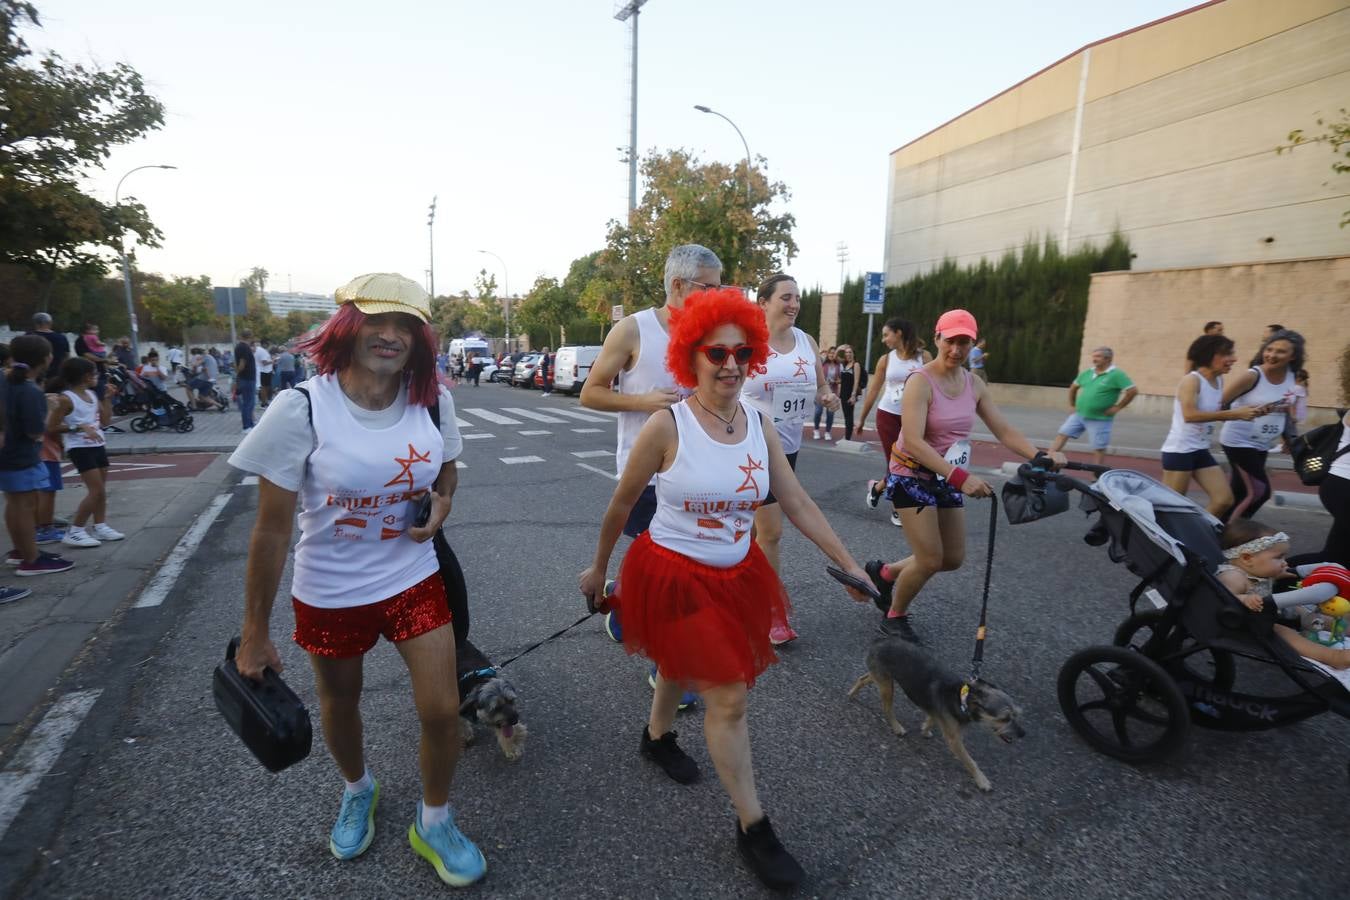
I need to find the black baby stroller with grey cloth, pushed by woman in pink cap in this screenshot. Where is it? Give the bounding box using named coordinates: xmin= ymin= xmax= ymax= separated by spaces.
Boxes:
xmin=1003 ymin=461 xmax=1350 ymax=762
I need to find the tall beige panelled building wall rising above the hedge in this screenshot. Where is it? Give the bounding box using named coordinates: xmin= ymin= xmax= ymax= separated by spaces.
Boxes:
xmin=886 ymin=0 xmax=1350 ymax=283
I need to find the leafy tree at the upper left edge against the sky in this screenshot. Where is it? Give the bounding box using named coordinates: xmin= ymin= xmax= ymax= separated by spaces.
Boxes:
xmin=0 ymin=0 xmax=163 ymax=290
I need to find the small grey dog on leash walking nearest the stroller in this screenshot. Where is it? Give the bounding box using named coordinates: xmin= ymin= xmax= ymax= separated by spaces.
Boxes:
xmin=848 ymin=637 xmax=1026 ymax=791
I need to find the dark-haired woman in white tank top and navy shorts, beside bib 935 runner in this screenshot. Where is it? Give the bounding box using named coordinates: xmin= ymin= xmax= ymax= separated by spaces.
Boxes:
xmin=1162 ymin=335 xmax=1261 ymax=518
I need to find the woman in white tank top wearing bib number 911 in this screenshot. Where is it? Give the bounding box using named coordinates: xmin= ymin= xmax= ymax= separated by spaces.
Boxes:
xmin=741 ymin=275 xmax=840 ymax=644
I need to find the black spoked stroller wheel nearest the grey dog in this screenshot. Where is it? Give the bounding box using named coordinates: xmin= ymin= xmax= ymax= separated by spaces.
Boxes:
xmin=1057 ymin=646 xmax=1191 ymax=762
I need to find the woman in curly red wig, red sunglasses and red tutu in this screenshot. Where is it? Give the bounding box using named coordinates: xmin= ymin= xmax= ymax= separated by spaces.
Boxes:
xmin=581 ymin=289 xmax=867 ymax=888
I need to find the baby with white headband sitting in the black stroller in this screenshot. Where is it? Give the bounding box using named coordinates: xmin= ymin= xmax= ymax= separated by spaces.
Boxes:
xmin=1216 ymin=518 xmax=1350 ymax=669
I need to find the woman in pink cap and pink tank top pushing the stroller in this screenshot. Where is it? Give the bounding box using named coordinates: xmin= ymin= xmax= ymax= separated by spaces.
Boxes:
xmin=864 ymin=309 xmax=1067 ymax=644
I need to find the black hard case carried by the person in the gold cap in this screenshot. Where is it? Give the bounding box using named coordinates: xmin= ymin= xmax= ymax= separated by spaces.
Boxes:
xmin=211 ymin=637 xmax=315 ymax=772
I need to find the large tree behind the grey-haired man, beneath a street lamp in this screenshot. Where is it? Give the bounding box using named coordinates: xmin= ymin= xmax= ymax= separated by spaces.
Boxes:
xmin=599 ymin=150 xmax=797 ymax=312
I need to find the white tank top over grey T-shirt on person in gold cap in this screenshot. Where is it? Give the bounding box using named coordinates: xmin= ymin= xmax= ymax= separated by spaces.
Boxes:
xmin=290 ymin=375 xmax=444 ymax=609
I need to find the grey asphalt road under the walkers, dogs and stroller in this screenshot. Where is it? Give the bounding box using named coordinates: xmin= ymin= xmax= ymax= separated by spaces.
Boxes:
xmin=0 ymin=385 xmax=1350 ymax=899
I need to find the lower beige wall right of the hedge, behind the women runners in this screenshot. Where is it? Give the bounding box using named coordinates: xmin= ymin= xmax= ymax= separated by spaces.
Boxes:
xmin=1079 ymin=256 xmax=1350 ymax=407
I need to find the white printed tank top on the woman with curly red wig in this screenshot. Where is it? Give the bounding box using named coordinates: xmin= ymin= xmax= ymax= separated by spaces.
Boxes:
xmin=648 ymin=399 xmax=770 ymax=568
